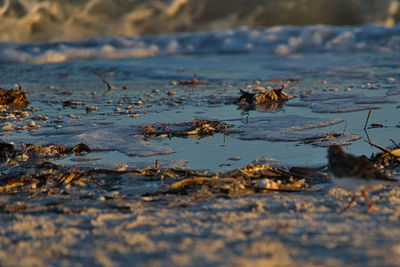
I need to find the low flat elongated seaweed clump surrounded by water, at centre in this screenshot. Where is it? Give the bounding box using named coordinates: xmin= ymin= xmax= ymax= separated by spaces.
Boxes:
xmin=138 ymin=120 xmax=229 ymax=139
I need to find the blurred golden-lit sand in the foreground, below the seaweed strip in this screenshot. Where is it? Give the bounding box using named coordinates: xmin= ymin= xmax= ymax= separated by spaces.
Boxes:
xmin=0 ymin=176 xmax=400 ymax=266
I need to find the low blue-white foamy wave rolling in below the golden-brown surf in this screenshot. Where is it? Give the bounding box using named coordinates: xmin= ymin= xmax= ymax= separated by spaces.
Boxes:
xmin=0 ymin=24 xmax=400 ymax=64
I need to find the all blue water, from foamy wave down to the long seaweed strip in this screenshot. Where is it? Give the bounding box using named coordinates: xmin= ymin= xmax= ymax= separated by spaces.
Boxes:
xmin=0 ymin=24 xmax=400 ymax=171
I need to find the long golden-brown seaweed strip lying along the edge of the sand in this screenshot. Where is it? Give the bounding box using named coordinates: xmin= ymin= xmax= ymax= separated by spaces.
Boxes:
xmin=0 ymin=153 xmax=325 ymax=201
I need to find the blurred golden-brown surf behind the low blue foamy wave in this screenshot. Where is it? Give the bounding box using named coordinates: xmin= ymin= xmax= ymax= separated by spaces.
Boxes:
xmin=0 ymin=0 xmax=400 ymax=42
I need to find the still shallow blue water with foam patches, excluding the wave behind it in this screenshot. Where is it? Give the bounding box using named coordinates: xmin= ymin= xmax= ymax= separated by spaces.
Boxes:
xmin=0 ymin=52 xmax=400 ymax=171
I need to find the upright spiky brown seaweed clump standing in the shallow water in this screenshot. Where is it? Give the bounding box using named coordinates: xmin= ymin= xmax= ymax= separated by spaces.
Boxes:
xmin=237 ymin=86 xmax=293 ymax=110
